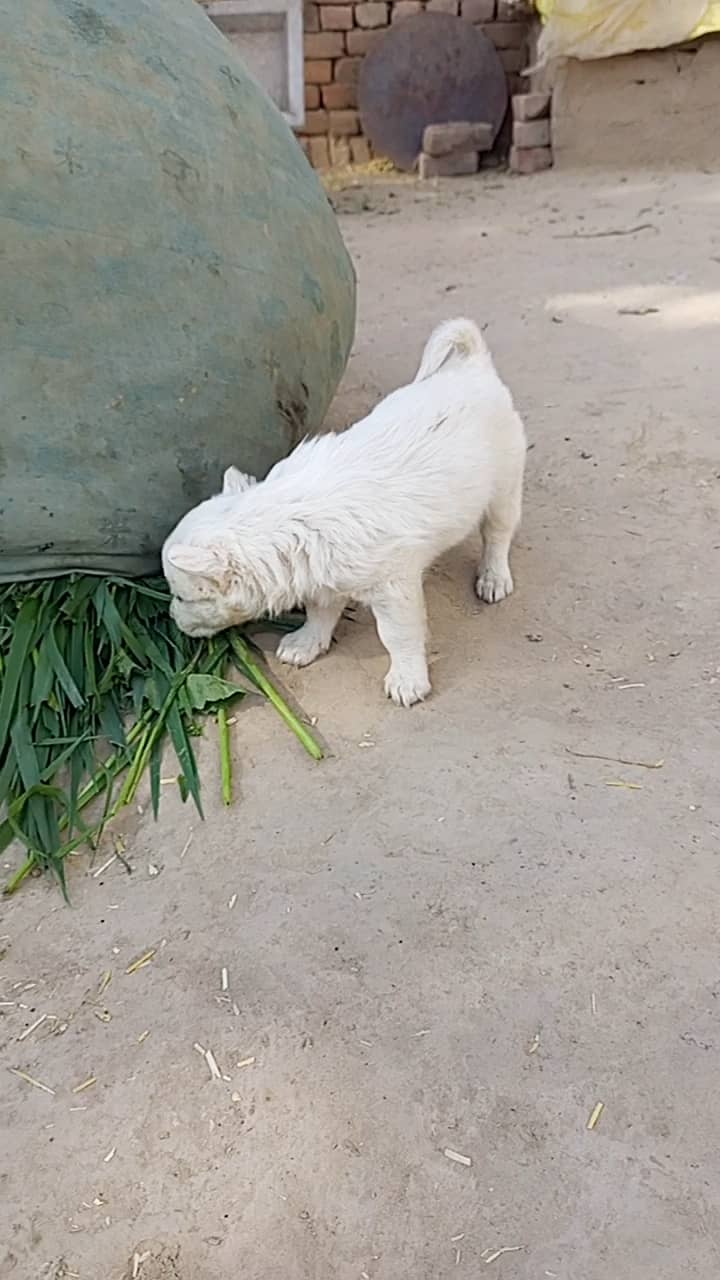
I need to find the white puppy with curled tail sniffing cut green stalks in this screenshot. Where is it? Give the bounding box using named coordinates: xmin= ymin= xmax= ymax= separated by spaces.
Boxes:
xmin=163 ymin=320 xmax=525 ymax=707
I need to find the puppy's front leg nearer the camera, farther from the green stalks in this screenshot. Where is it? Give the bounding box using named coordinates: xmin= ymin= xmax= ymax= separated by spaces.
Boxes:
xmin=370 ymin=575 xmax=430 ymax=707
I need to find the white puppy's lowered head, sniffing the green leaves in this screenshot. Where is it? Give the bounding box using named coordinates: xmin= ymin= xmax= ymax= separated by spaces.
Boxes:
xmin=163 ymin=467 xmax=265 ymax=636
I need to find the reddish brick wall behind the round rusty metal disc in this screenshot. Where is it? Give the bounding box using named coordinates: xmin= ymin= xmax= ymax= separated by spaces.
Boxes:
xmin=297 ymin=0 xmax=529 ymax=169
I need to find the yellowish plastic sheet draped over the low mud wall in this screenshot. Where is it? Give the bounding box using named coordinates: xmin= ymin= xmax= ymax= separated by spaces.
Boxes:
xmin=536 ymin=0 xmax=720 ymax=63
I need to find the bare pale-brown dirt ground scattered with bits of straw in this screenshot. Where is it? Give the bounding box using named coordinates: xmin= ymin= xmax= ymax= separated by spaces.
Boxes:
xmin=0 ymin=173 xmax=720 ymax=1280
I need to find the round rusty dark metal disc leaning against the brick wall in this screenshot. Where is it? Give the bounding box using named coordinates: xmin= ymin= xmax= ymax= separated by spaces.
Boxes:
xmin=357 ymin=13 xmax=507 ymax=169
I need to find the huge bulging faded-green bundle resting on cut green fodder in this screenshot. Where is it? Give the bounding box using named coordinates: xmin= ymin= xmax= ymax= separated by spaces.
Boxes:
xmin=0 ymin=0 xmax=355 ymax=580
